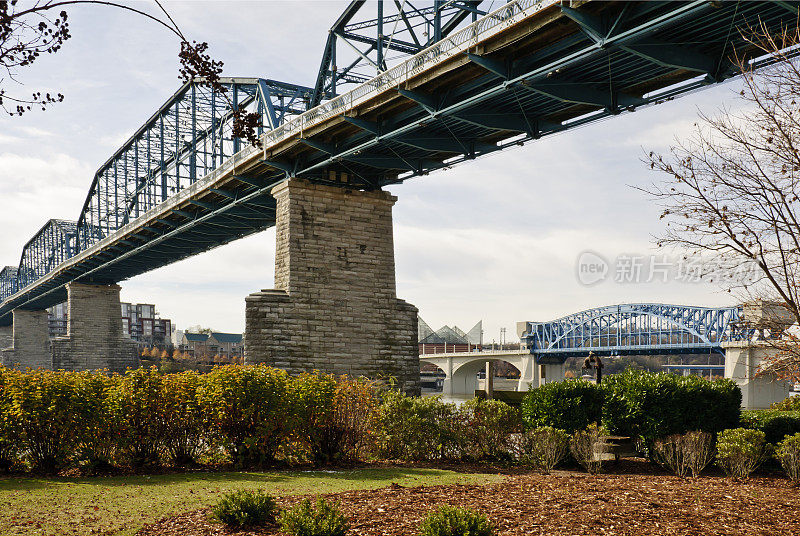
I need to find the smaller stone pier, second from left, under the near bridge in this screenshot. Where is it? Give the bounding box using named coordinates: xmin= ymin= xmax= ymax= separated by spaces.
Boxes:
xmin=53 ymin=283 xmax=139 ymax=373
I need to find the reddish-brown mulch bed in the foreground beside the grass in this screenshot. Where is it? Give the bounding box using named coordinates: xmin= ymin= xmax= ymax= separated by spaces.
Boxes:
xmin=137 ymin=466 xmax=800 ymax=536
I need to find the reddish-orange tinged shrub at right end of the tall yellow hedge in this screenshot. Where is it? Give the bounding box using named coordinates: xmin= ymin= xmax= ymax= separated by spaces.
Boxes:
xmin=293 ymin=373 xmax=378 ymax=463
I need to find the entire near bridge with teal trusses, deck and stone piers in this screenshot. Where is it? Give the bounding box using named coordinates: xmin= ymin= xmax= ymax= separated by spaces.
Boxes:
xmin=0 ymin=0 xmax=800 ymax=388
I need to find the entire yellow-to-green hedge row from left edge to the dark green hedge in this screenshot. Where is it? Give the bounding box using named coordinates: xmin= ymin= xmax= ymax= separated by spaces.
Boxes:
xmin=0 ymin=365 xmax=520 ymax=473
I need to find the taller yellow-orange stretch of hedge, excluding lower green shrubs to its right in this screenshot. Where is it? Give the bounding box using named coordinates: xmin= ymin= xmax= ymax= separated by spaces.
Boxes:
xmin=0 ymin=365 xmax=378 ymax=472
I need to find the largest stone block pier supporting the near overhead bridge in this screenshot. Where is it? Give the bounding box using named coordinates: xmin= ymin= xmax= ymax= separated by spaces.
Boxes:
xmin=245 ymin=179 xmax=419 ymax=393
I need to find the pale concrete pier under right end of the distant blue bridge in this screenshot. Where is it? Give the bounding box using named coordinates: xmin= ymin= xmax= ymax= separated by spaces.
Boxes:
xmin=722 ymin=341 xmax=792 ymax=409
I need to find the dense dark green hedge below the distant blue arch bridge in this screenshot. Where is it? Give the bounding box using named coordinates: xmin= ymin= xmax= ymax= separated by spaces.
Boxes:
xmin=522 ymin=370 xmax=742 ymax=447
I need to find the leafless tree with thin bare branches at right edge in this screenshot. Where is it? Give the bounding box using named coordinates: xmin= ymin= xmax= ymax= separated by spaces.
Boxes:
xmin=645 ymin=19 xmax=800 ymax=378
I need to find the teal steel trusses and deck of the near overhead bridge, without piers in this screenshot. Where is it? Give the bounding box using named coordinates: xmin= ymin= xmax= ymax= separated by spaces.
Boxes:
xmin=0 ymin=0 xmax=800 ymax=324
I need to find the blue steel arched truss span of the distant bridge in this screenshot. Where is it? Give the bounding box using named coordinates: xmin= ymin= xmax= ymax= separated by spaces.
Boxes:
xmin=522 ymin=303 xmax=754 ymax=363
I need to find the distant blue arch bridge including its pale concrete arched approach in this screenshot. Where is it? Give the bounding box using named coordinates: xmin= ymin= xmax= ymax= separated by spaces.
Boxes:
xmin=420 ymin=303 xmax=756 ymax=395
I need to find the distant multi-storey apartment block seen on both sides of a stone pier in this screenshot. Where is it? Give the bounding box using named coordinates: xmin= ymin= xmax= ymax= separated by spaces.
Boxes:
xmin=47 ymin=303 xmax=173 ymax=347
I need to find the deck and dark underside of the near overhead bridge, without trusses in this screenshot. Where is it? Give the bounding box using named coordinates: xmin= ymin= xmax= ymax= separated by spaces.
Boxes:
xmin=0 ymin=0 xmax=800 ymax=323
